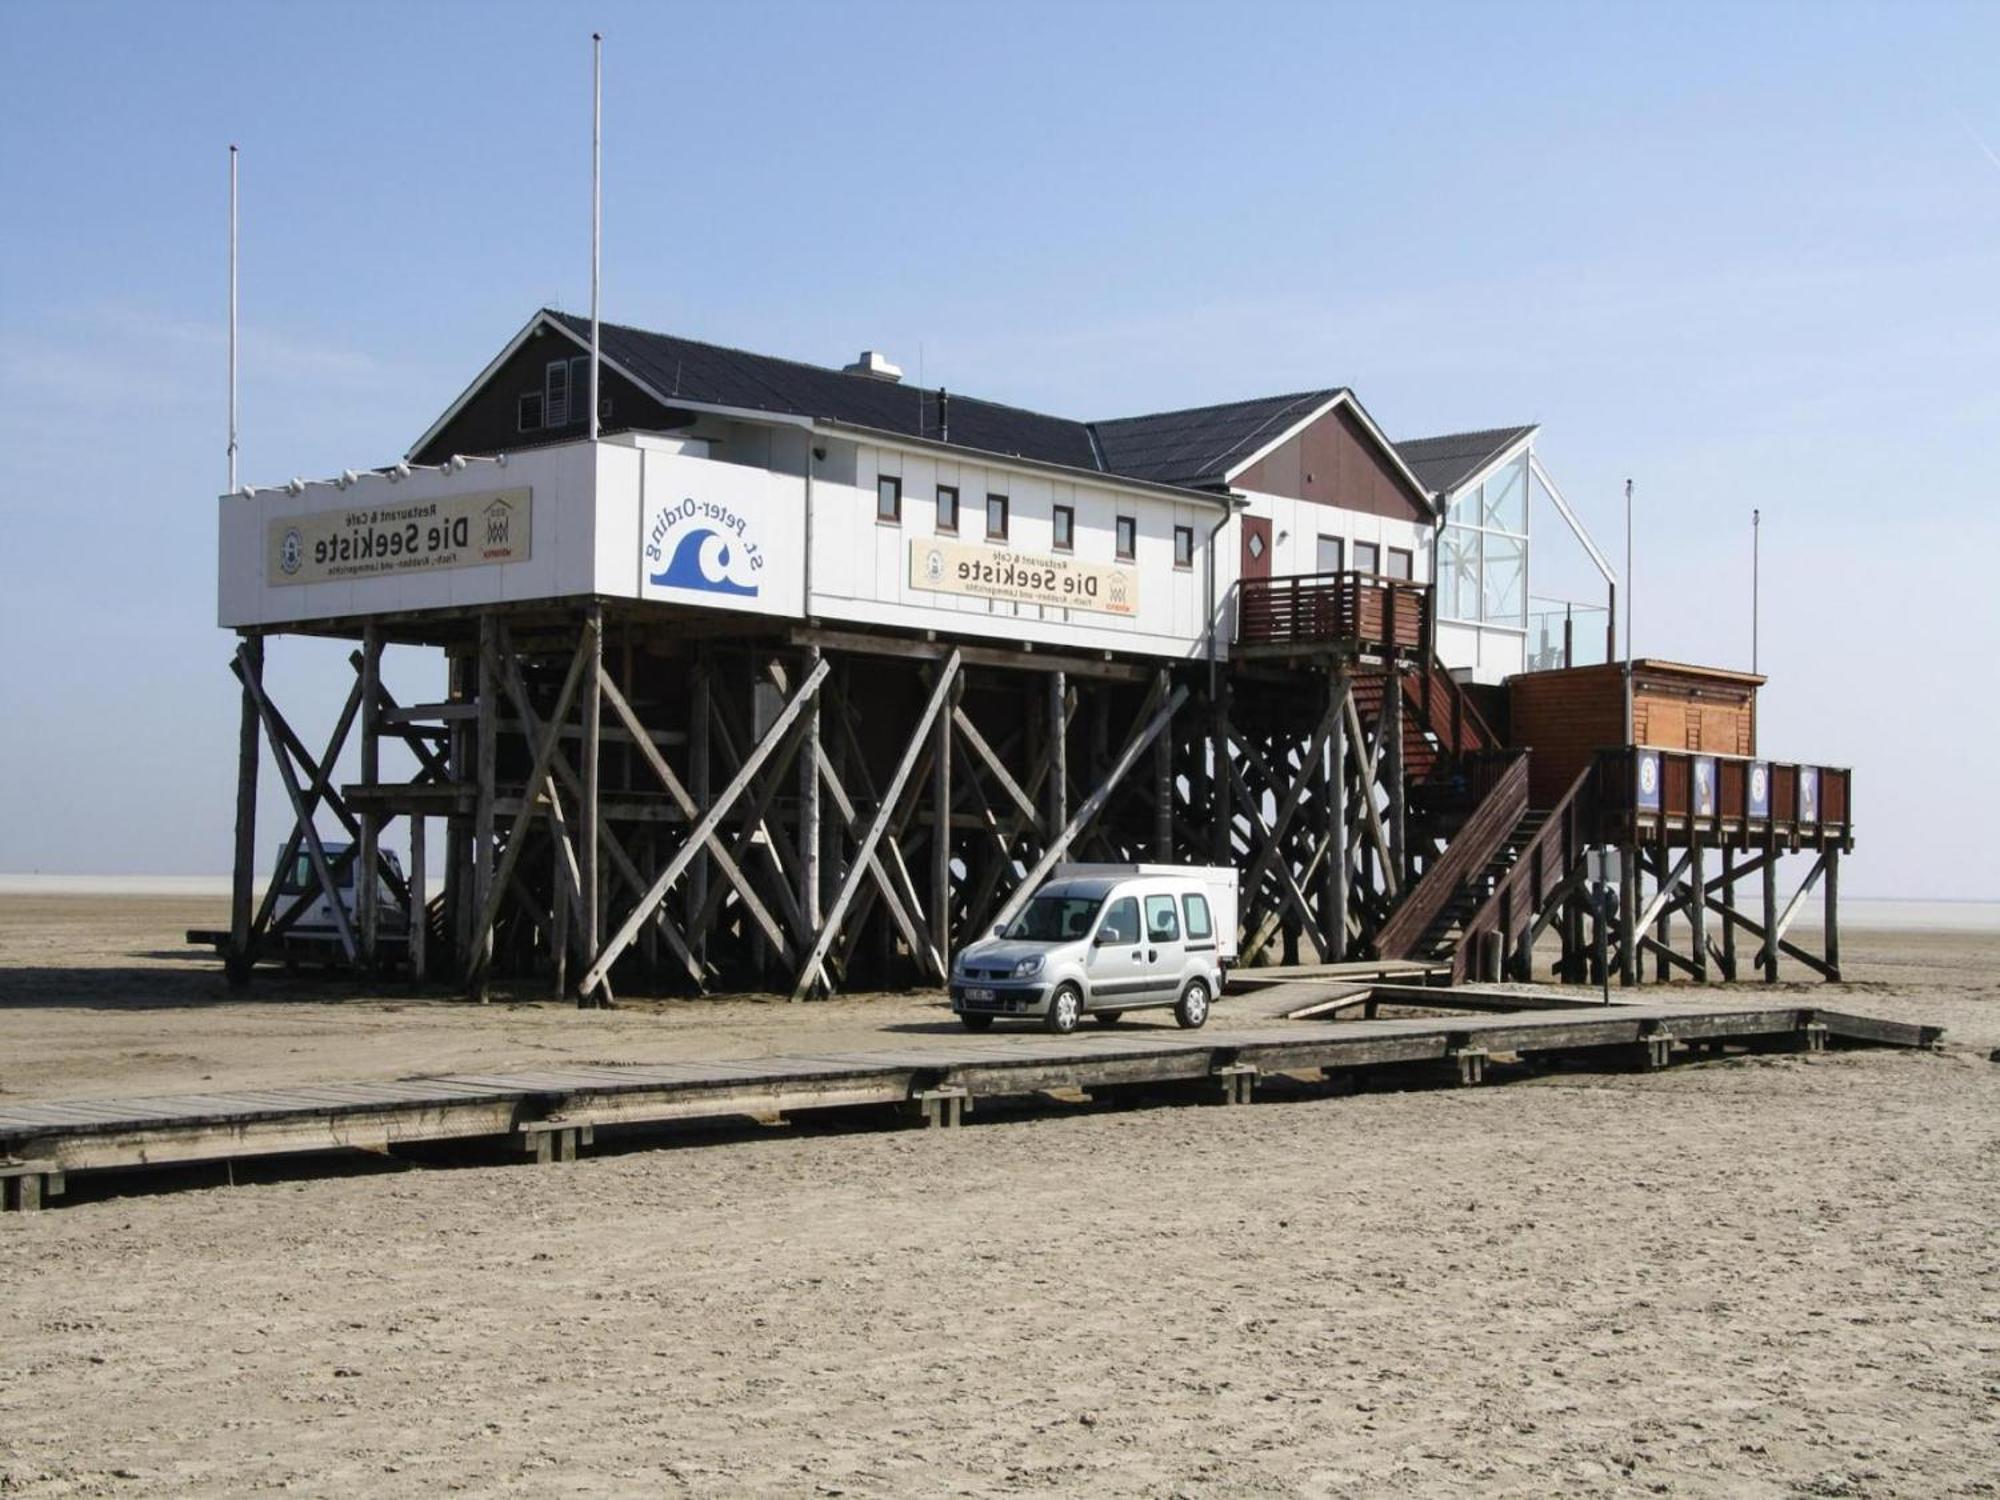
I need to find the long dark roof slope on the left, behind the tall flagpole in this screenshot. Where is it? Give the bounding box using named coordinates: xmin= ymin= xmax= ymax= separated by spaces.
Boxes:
xmin=548 ymin=312 xmax=1098 ymax=478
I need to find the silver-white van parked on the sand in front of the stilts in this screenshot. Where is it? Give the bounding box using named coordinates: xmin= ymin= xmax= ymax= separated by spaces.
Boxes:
xmin=952 ymin=864 xmax=1236 ymax=1034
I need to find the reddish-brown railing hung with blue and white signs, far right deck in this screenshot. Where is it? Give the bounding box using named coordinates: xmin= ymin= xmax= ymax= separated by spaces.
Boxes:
xmin=1598 ymin=746 xmax=1854 ymax=842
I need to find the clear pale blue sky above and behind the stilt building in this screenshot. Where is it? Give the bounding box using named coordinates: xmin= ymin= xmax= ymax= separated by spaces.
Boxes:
xmin=0 ymin=0 xmax=2000 ymax=896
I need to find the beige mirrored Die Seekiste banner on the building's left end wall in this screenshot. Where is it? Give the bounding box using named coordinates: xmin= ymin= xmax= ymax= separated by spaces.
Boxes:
xmin=264 ymin=488 xmax=534 ymax=584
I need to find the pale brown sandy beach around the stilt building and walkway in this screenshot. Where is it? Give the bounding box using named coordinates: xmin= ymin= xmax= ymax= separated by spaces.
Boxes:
xmin=0 ymin=896 xmax=2000 ymax=1496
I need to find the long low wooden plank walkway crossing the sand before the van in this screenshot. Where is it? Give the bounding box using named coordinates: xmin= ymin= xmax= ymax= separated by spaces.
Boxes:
xmin=0 ymin=992 xmax=1942 ymax=1208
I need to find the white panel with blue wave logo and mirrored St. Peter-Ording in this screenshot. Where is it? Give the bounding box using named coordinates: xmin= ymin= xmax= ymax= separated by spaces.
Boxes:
xmin=638 ymin=454 xmax=806 ymax=614
